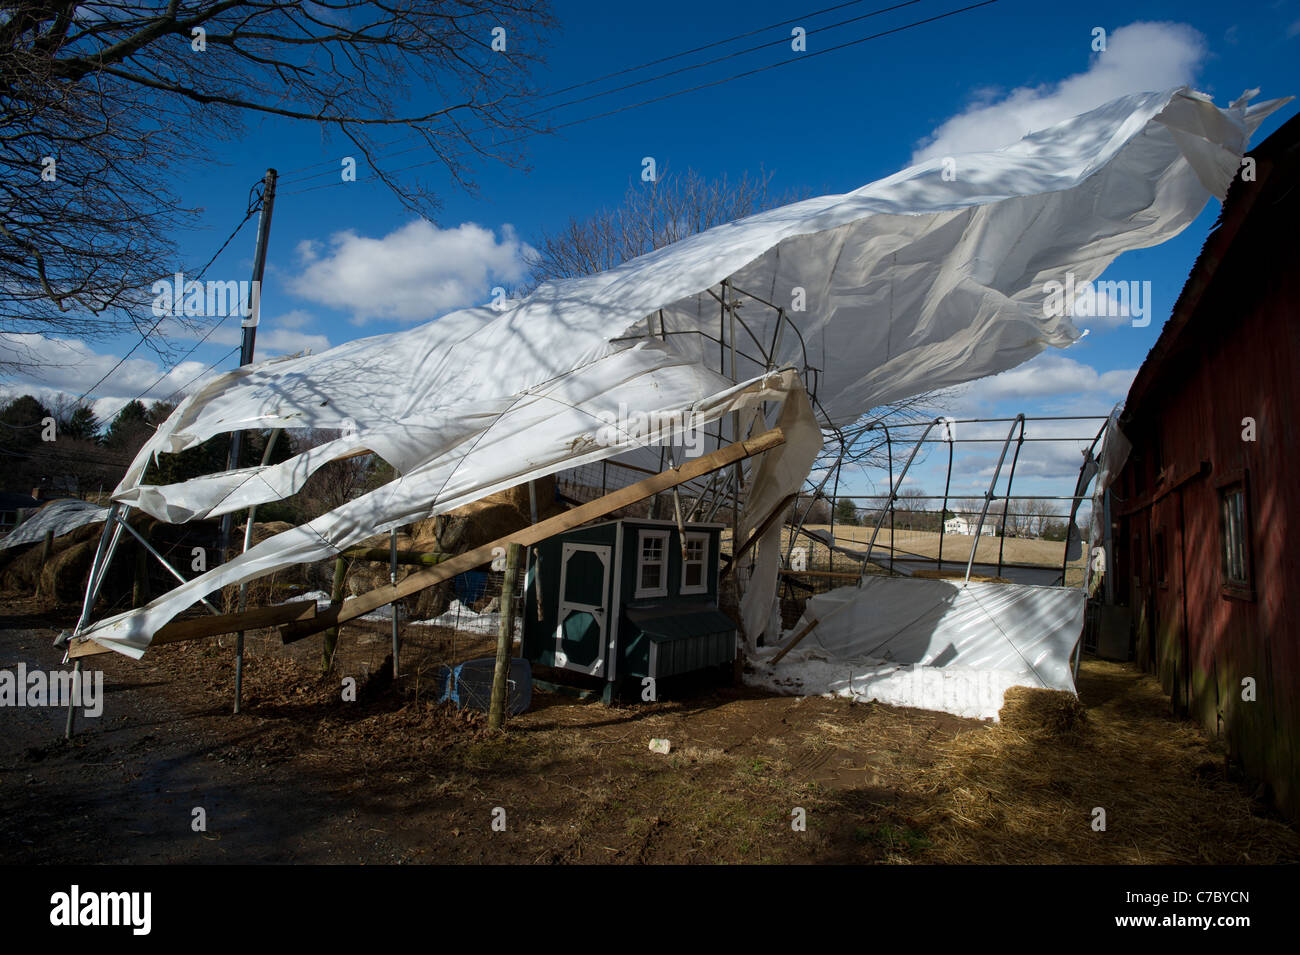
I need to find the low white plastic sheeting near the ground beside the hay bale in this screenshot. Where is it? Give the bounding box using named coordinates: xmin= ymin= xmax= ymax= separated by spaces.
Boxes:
xmin=745 ymin=577 xmax=1087 ymax=719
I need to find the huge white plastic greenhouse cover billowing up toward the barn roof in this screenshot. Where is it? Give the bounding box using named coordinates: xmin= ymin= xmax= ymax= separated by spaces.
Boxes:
xmin=76 ymin=88 xmax=1281 ymax=656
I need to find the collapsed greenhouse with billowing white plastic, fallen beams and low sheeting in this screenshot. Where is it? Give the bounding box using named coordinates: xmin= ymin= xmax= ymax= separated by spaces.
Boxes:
xmin=53 ymin=87 xmax=1279 ymax=712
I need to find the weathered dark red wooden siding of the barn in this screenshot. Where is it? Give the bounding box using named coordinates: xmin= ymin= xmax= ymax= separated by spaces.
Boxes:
xmin=1117 ymin=143 xmax=1300 ymax=817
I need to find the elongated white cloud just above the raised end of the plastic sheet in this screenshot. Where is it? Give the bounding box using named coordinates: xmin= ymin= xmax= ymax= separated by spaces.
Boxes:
xmin=911 ymin=22 xmax=1206 ymax=162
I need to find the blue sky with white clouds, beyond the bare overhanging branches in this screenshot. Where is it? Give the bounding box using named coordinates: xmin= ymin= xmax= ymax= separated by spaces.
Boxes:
xmin=5 ymin=0 xmax=1300 ymax=514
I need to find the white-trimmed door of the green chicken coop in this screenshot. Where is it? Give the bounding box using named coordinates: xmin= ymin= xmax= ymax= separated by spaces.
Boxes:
xmin=555 ymin=543 xmax=611 ymax=677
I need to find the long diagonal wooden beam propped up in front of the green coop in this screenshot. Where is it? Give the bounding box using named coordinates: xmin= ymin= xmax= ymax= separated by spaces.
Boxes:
xmin=282 ymin=427 xmax=785 ymax=642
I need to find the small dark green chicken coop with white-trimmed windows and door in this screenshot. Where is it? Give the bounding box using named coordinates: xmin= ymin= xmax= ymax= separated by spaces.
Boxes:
xmin=523 ymin=518 xmax=736 ymax=700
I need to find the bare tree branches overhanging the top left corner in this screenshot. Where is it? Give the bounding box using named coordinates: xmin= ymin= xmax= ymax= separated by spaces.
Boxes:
xmin=0 ymin=0 xmax=551 ymax=370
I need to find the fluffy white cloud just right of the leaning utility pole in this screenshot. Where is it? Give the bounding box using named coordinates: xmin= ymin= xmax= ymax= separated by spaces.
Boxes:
xmin=290 ymin=220 xmax=530 ymax=322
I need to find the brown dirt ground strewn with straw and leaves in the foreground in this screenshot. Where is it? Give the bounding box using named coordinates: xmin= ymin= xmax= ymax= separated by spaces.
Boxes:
xmin=0 ymin=595 xmax=1300 ymax=863
